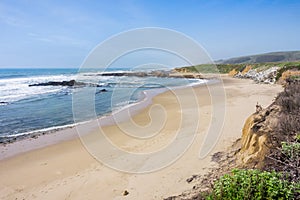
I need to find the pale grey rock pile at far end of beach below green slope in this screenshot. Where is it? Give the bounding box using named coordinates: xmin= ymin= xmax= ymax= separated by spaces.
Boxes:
xmin=234 ymin=67 xmax=278 ymax=84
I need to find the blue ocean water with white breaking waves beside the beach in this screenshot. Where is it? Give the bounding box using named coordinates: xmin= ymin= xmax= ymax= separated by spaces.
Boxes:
xmin=0 ymin=68 xmax=204 ymax=139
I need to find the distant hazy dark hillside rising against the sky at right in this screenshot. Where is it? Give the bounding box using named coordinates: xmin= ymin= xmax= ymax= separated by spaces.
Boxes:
xmin=216 ymin=51 xmax=300 ymax=64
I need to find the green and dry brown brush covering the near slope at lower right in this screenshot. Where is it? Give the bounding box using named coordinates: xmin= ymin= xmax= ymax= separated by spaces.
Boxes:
xmin=199 ymin=81 xmax=300 ymax=200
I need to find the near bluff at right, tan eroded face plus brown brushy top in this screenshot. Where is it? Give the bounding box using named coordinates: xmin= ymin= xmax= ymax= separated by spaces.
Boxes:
xmin=237 ymin=80 xmax=300 ymax=167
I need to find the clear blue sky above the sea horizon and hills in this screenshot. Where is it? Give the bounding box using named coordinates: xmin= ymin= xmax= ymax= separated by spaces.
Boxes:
xmin=0 ymin=0 xmax=300 ymax=68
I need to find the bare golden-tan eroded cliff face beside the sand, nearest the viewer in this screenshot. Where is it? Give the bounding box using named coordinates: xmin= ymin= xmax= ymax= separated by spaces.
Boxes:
xmin=237 ymin=103 xmax=280 ymax=168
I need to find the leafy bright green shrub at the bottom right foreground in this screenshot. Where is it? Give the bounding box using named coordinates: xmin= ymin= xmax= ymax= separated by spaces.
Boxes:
xmin=206 ymin=170 xmax=296 ymax=200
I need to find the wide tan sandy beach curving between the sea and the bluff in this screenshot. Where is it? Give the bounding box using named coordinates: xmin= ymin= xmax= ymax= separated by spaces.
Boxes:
xmin=0 ymin=76 xmax=282 ymax=200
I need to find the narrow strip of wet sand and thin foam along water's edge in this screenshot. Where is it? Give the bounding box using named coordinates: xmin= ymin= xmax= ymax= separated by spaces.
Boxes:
xmin=0 ymin=79 xmax=209 ymax=161
